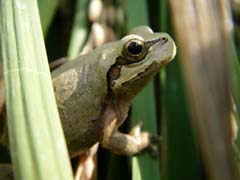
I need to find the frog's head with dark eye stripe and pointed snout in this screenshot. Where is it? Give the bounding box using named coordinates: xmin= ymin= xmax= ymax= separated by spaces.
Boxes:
xmin=108 ymin=26 xmax=176 ymax=99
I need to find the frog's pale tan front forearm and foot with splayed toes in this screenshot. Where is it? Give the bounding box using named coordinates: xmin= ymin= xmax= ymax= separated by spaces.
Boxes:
xmin=101 ymin=123 xmax=160 ymax=157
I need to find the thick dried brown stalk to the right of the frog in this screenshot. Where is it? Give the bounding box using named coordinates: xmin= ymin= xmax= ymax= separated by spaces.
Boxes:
xmin=170 ymin=0 xmax=237 ymax=180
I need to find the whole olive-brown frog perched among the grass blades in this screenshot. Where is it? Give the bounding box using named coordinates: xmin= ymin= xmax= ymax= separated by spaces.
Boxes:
xmin=52 ymin=26 xmax=176 ymax=155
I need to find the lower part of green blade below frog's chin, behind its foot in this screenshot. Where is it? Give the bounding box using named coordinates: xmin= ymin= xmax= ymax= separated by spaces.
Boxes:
xmin=132 ymin=84 xmax=160 ymax=180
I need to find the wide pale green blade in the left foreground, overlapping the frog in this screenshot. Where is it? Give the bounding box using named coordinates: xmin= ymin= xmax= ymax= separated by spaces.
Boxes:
xmin=0 ymin=0 xmax=72 ymax=180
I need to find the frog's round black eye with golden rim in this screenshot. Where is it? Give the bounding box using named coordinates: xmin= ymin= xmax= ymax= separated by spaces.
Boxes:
xmin=123 ymin=39 xmax=147 ymax=63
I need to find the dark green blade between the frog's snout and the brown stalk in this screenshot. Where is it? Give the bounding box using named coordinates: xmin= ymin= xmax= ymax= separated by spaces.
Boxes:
xmin=159 ymin=0 xmax=201 ymax=180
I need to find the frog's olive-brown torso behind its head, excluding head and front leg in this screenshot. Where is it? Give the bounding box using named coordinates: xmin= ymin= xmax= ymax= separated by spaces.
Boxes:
xmin=52 ymin=48 xmax=111 ymax=154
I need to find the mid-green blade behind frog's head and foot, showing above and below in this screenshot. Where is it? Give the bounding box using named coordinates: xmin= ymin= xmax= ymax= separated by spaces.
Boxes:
xmin=126 ymin=0 xmax=160 ymax=180
